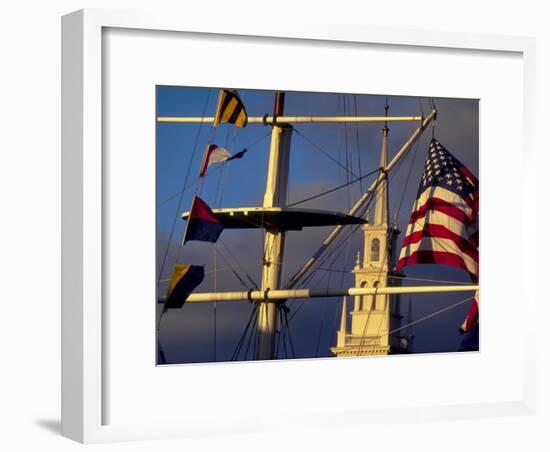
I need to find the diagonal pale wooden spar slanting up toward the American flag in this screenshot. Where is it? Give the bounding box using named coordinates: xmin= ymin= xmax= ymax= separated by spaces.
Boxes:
xmin=288 ymin=109 xmax=437 ymax=289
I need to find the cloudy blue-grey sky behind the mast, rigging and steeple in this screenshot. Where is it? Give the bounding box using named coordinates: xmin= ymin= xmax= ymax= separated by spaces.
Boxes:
xmin=156 ymin=87 xmax=478 ymax=363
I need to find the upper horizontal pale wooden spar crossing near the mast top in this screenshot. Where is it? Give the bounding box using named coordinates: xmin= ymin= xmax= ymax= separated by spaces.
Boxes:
xmin=157 ymin=116 xmax=423 ymax=124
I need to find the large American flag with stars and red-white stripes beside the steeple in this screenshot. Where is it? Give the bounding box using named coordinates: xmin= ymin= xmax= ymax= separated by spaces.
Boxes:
xmin=396 ymin=139 xmax=479 ymax=282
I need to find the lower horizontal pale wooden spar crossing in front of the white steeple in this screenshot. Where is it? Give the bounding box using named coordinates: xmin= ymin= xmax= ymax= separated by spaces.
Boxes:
xmin=159 ymin=284 xmax=479 ymax=304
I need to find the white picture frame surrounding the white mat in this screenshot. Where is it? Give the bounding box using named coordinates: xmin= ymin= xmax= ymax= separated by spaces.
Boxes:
xmin=62 ymin=10 xmax=536 ymax=443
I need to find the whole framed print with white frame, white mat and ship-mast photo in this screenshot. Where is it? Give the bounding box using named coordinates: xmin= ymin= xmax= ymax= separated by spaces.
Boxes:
xmin=62 ymin=10 xmax=534 ymax=442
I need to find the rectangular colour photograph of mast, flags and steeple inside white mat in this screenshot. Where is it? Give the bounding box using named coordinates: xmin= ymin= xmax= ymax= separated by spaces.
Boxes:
xmin=155 ymin=85 xmax=481 ymax=366
